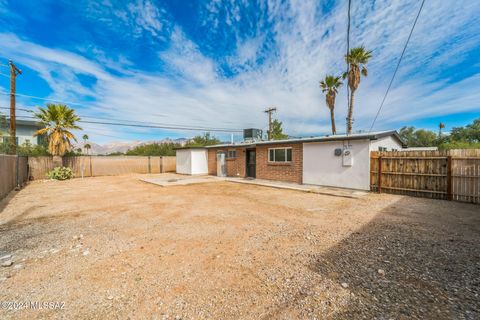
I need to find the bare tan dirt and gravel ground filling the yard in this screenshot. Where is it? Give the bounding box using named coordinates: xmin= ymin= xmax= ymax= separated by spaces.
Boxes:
xmin=0 ymin=176 xmax=480 ymax=319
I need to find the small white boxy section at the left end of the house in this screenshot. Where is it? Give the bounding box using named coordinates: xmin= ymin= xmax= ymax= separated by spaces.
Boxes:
xmin=176 ymin=149 xmax=208 ymax=174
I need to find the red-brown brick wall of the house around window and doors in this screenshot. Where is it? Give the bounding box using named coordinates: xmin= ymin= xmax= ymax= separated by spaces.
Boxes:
xmin=208 ymin=143 xmax=303 ymax=183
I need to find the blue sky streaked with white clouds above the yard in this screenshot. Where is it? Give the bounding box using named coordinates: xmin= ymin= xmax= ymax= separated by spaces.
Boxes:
xmin=0 ymin=0 xmax=480 ymax=143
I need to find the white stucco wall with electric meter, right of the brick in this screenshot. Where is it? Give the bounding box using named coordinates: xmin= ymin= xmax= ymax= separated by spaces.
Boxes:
xmin=303 ymin=140 xmax=370 ymax=190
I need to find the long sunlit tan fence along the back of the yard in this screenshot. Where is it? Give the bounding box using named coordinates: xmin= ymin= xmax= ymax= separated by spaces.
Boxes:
xmin=28 ymin=156 xmax=175 ymax=179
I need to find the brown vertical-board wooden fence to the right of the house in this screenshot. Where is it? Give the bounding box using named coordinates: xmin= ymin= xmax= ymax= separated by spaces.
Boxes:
xmin=370 ymin=149 xmax=480 ymax=203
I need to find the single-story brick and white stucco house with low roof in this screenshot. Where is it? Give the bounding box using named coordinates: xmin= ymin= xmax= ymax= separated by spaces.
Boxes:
xmin=177 ymin=131 xmax=404 ymax=190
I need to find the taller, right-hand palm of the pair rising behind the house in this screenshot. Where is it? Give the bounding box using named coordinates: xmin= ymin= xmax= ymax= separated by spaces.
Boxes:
xmin=343 ymin=46 xmax=372 ymax=134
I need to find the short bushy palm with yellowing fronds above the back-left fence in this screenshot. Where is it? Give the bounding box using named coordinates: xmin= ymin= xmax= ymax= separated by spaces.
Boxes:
xmin=34 ymin=103 xmax=82 ymax=156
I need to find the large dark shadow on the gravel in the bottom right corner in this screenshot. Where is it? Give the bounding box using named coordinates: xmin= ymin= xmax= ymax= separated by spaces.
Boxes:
xmin=311 ymin=197 xmax=480 ymax=319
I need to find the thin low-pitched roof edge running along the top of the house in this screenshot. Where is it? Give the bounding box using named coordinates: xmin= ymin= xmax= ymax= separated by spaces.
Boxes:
xmin=204 ymin=130 xmax=405 ymax=148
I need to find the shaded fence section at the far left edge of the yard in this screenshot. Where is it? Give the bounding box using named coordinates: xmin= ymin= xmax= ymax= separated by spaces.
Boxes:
xmin=0 ymin=155 xmax=28 ymax=199
